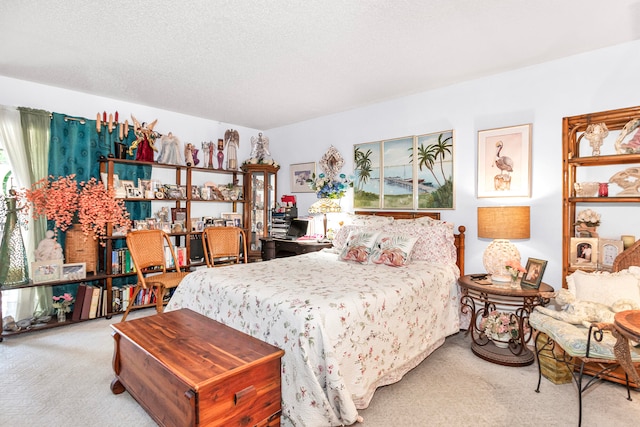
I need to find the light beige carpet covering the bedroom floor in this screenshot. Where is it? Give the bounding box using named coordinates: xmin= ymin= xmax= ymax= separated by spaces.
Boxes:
xmin=0 ymin=309 xmax=640 ymax=427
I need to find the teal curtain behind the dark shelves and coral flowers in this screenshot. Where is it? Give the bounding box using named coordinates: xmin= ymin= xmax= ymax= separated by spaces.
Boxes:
xmin=49 ymin=113 xmax=152 ymax=295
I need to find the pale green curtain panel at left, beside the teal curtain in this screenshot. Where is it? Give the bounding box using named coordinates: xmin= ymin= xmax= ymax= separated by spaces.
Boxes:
xmin=18 ymin=107 xmax=53 ymax=317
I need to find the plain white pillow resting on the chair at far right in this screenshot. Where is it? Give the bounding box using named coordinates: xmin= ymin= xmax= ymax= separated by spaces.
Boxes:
xmin=567 ymin=270 xmax=640 ymax=306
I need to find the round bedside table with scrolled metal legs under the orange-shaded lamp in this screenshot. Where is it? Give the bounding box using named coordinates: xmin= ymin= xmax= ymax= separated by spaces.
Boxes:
xmin=458 ymin=276 xmax=553 ymax=366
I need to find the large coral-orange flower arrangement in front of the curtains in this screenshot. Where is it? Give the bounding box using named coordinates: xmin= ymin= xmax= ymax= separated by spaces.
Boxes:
xmin=26 ymin=174 xmax=131 ymax=239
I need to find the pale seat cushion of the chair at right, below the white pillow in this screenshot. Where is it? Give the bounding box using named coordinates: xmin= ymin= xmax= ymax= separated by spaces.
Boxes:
xmin=529 ymin=307 xmax=640 ymax=363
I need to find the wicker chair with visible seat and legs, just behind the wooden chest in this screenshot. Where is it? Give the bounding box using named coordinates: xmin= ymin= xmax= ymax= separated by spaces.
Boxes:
xmin=121 ymin=230 xmax=189 ymax=322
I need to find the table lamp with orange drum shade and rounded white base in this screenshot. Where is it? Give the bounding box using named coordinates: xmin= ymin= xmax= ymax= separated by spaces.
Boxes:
xmin=478 ymin=206 xmax=530 ymax=282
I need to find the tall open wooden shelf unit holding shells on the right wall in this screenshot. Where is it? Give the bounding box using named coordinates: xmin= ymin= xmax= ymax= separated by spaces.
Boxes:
xmin=562 ymin=107 xmax=640 ymax=287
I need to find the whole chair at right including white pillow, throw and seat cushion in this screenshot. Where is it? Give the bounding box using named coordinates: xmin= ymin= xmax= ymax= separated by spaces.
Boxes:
xmin=529 ymin=242 xmax=640 ymax=425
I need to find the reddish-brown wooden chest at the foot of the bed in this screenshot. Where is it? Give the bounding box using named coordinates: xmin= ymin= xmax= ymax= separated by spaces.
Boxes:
xmin=111 ymin=309 xmax=284 ymax=427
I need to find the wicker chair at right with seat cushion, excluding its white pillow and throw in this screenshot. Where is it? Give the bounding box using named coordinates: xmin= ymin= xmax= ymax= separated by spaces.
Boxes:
xmin=529 ymin=241 xmax=640 ymax=426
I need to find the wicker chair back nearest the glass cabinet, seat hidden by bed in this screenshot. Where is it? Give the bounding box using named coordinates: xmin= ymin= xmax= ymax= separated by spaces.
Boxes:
xmin=202 ymin=227 xmax=247 ymax=267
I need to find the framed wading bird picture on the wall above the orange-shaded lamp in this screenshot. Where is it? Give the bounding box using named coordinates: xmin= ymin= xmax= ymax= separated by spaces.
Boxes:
xmin=478 ymin=124 xmax=531 ymax=197
